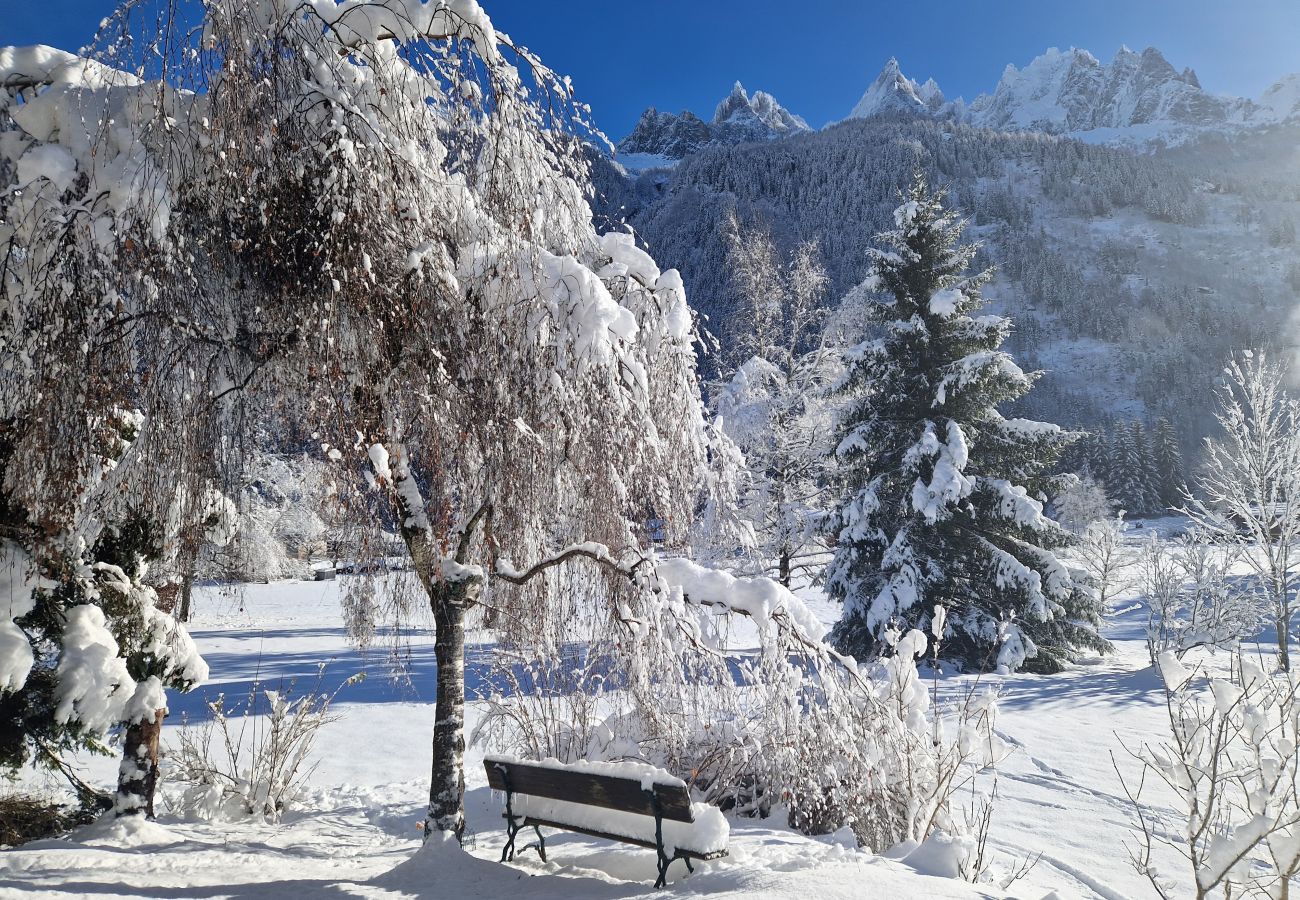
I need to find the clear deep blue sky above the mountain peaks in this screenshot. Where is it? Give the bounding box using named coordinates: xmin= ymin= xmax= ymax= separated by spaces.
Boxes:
xmin=0 ymin=0 xmax=1300 ymax=139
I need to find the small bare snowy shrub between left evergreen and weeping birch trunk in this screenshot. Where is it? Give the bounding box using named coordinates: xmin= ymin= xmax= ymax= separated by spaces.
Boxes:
xmin=168 ymin=665 xmax=360 ymax=822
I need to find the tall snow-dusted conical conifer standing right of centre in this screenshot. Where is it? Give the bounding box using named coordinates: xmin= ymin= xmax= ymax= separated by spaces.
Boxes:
xmin=827 ymin=174 xmax=1108 ymax=671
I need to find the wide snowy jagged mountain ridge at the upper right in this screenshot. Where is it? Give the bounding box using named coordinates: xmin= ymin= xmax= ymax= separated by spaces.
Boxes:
xmin=849 ymin=47 xmax=1300 ymax=137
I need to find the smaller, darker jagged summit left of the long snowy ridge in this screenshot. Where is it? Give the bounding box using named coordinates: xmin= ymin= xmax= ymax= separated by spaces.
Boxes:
xmin=618 ymin=82 xmax=811 ymax=160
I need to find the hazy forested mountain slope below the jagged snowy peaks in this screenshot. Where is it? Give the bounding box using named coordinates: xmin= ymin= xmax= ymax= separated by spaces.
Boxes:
xmin=595 ymin=116 xmax=1300 ymax=445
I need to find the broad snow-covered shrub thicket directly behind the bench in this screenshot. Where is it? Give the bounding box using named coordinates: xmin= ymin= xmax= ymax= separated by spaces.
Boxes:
xmin=476 ymin=559 xmax=1002 ymax=851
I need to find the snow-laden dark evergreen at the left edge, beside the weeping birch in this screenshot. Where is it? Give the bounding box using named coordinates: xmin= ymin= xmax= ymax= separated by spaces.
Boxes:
xmin=0 ymin=415 xmax=208 ymax=815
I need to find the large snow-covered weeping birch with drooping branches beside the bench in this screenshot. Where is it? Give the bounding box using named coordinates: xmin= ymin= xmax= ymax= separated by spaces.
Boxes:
xmin=5 ymin=0 xmax=703 ymax=836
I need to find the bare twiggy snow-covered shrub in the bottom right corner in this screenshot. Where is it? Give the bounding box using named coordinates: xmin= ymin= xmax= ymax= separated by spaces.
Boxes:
xmin=1121 ymin=650 xmax=1300 ymax=900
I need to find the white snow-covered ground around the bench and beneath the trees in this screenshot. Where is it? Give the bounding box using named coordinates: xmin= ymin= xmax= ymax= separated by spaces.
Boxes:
xmin=0 ymin=551 xmax=1274 ymax=900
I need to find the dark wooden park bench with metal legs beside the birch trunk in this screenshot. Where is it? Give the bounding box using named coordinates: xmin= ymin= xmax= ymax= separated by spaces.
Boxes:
xmin=484 ymin=757 xmax=727 ymax=887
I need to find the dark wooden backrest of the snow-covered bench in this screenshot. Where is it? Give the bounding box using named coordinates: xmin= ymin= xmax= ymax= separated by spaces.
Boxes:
xmin=484 ymin=757 xmax=696 ymax=822
